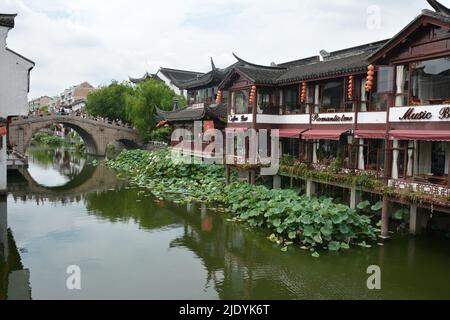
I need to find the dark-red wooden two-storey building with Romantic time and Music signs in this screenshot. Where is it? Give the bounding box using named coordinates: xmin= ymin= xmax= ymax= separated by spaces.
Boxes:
xmin=218 ymin=0 xmax=450 ymax=237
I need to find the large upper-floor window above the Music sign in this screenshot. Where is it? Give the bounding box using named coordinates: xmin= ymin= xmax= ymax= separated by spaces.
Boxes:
xmin=411 ymin=57 xmax=450 ymax=105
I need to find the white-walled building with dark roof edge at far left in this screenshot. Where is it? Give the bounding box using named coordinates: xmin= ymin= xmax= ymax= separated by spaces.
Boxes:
xmin=0 ymin=13 xmax=34 ymax=192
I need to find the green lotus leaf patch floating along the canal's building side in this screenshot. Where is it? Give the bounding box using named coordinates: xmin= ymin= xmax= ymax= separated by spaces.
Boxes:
xmin=107 ymin=150 xmax=379 ymax=252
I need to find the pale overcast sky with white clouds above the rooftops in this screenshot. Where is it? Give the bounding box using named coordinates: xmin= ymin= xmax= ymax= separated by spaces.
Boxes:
xmin=0 ymin=0 xmax=442 ymax=98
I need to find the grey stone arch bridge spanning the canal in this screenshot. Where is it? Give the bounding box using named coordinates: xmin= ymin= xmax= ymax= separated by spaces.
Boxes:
xmin=8 ymin=114 xmax=141 ymax=156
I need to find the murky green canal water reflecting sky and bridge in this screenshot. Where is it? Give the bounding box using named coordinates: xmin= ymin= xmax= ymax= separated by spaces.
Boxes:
xmin=0 ymin=149 xmax=450 ymax=299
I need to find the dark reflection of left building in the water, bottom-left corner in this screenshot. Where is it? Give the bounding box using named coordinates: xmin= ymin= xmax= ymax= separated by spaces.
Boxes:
xmin=0 ymin=197 xmax=31 ymax=300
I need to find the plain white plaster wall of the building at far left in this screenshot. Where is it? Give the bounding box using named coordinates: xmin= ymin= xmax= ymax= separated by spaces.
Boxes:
xmin=0 ymin=27 xmax=33 ymax=118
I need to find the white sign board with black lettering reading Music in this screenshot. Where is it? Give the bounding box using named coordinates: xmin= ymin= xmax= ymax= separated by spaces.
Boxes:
xmin=389 ymin=105 xmax=450 ymax=122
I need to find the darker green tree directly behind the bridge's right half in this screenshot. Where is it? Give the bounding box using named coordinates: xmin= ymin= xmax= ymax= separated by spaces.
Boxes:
xmin=86 ymin=80 xmax=133 ymax=122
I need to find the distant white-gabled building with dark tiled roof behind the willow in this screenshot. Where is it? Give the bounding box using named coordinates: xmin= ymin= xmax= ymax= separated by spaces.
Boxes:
xmin=130 ymin=68 xmax=203 ymax=98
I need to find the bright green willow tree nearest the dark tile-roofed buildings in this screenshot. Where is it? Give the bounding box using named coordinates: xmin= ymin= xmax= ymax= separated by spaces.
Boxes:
xmin=126 ymin=79 xmax=186 ymax=139
